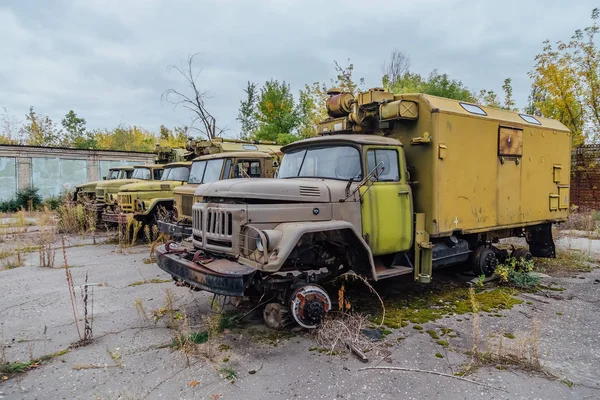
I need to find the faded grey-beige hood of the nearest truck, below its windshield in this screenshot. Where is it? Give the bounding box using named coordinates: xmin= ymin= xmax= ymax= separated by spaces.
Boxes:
xmin=195 ymin=178 xmax=356 ymax=203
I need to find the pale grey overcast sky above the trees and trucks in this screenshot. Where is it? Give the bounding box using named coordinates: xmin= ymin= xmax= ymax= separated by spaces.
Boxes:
xmin=0 ymin=0 xmax=597 ymax=137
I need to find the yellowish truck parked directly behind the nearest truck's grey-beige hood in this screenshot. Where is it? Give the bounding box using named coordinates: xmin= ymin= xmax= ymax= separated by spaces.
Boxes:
xmin=158 ymin=149 xmax=280 ymax=239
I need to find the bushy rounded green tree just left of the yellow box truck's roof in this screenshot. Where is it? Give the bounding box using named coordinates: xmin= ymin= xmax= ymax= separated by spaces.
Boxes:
xmin=252 ymin=79 xmax=300 ymax=141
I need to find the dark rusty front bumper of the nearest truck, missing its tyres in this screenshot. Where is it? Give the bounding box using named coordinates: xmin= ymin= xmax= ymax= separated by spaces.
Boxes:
xmin=156 ymin=242 xmax=256 ymax=296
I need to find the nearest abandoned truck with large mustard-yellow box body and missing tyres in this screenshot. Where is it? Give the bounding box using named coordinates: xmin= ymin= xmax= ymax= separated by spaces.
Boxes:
xmin=157 ymin=89 xmax=571 ymax=328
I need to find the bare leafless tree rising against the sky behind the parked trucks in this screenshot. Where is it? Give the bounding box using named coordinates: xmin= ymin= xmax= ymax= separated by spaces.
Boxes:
xmin=161 ymin=53 xmax=224 ymax=139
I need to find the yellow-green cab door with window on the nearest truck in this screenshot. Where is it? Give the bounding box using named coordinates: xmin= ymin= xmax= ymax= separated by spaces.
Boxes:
xmin=360 ymin=147 xmax=413 ymax=256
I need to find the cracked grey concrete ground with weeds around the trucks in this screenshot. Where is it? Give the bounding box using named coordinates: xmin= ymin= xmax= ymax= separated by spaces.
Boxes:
xmin=0 ymin=234 xmax=600 ymax=399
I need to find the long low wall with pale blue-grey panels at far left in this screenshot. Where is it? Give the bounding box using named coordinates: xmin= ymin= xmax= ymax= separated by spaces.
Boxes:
xmin=0 ymin=145 xmax=154 ymax=200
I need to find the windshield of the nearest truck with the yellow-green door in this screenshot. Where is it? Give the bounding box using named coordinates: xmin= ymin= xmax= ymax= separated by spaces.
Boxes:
xmin=277 ymin=146 xmax=362 ymax=180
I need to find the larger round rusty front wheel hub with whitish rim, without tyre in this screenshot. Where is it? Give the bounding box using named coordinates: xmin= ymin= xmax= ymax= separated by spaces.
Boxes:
xmin=290 ymin=285 xmax=331 ymax=329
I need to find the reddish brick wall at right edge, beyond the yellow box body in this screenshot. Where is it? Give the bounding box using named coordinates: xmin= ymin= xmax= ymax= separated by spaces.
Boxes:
xmin=570 ymin=144 xmax=600 ymax=210
